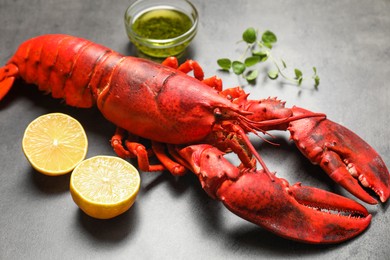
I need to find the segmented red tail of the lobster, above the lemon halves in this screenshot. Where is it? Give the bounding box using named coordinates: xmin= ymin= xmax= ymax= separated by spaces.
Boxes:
xmin=0 ymin=34 xmax=122 ymax=108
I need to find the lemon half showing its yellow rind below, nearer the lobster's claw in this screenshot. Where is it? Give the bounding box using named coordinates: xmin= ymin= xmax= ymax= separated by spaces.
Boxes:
xmin=70 ymin=156 xmax=141 ymax=219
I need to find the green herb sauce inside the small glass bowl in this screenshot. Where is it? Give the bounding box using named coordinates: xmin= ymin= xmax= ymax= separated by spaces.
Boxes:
xmin=132 ymin=9 xmax=192 ymax=40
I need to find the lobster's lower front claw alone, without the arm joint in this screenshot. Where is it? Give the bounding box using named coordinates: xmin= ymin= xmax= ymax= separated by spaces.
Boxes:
xmin=217 ymin=171 xmax=371 ymax=244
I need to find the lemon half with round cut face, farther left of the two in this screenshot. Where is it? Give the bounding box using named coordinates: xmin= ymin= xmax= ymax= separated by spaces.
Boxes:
xmin=22 ymin=113 xmax=88 ymax=176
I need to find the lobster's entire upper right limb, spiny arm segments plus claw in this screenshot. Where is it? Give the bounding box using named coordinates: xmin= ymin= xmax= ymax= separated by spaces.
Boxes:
xmin=222 ymin=87 xmax=390 ymax=204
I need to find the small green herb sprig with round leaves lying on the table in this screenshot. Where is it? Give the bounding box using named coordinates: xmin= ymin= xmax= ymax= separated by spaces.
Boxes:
xmin=217 ymin=27 xmax=320 ymax=89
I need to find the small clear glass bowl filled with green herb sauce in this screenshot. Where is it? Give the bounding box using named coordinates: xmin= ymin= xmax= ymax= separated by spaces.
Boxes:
xmin=125 ymin=0 xmax=198 ymax=58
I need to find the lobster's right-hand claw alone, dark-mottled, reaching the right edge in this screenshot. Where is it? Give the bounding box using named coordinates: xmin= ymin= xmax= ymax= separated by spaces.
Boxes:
xmin=288 ymin=107 xmax=390 ymax=204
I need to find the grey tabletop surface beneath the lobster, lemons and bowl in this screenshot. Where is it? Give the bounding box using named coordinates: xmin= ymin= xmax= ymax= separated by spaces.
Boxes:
xmin=0 ymin=0 xmax=390 ymax=259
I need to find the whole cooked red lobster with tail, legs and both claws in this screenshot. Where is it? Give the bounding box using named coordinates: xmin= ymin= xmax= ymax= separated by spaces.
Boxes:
xmin=0 ymin=35 xmax=390 ymax=243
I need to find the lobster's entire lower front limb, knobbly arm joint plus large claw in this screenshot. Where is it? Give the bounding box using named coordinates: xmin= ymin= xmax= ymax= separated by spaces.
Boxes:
xmin=176 ymin=144 xmax=371 ymax=243
